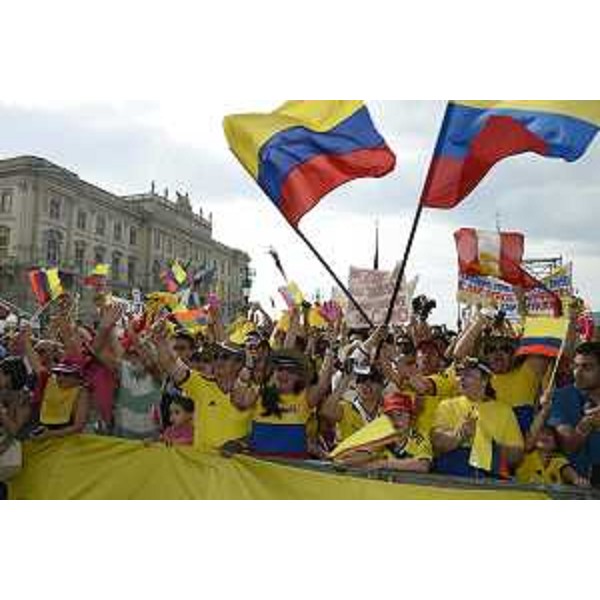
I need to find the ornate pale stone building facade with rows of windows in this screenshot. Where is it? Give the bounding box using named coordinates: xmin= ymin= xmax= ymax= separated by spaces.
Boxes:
xmin=0 ymin=156 xmax=251 ymax=318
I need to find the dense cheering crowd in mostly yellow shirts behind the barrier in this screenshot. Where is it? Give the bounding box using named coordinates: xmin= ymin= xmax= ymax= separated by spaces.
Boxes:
xmin=0 ymin=294 xmax=600 ymax=497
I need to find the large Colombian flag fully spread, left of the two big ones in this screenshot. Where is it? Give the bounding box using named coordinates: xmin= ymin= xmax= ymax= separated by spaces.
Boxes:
xmin=223 ymin=100 xmax=396 ymax=227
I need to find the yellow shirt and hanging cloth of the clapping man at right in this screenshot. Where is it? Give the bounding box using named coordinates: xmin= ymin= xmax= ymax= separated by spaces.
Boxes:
xmin=433 ymin=396 xmax=523 ymax=471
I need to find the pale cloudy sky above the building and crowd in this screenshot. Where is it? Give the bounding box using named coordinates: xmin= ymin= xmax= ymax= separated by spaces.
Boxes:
xmin=0 ymin=96 xmax=600 ymax=323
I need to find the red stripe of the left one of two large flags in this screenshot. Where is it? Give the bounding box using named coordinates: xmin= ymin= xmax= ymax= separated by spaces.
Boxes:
xmin=279 ymin=146 xmax=396 ymax=227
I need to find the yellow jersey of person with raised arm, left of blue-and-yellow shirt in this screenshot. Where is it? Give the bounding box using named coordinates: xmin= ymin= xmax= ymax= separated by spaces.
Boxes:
xmin=181 ymin=371 xmax=252 ymax=450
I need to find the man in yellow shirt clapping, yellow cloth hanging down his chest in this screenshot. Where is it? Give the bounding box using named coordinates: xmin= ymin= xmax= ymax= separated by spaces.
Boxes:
xmin=431 ymin=358 xmax=523 ymax=477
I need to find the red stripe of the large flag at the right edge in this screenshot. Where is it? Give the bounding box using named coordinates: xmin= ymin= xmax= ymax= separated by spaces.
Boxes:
xmin=421 ymin=116 xmax=547 ymax=208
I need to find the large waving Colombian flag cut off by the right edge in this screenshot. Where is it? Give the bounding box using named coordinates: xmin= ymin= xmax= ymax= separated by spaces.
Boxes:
xmin=421 ymin=100 xmax=600 ymax=208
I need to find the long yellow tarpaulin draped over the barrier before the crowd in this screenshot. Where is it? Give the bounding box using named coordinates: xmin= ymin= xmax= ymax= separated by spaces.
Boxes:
xmin=10 ymin=435 xmax=547 ymax=500
